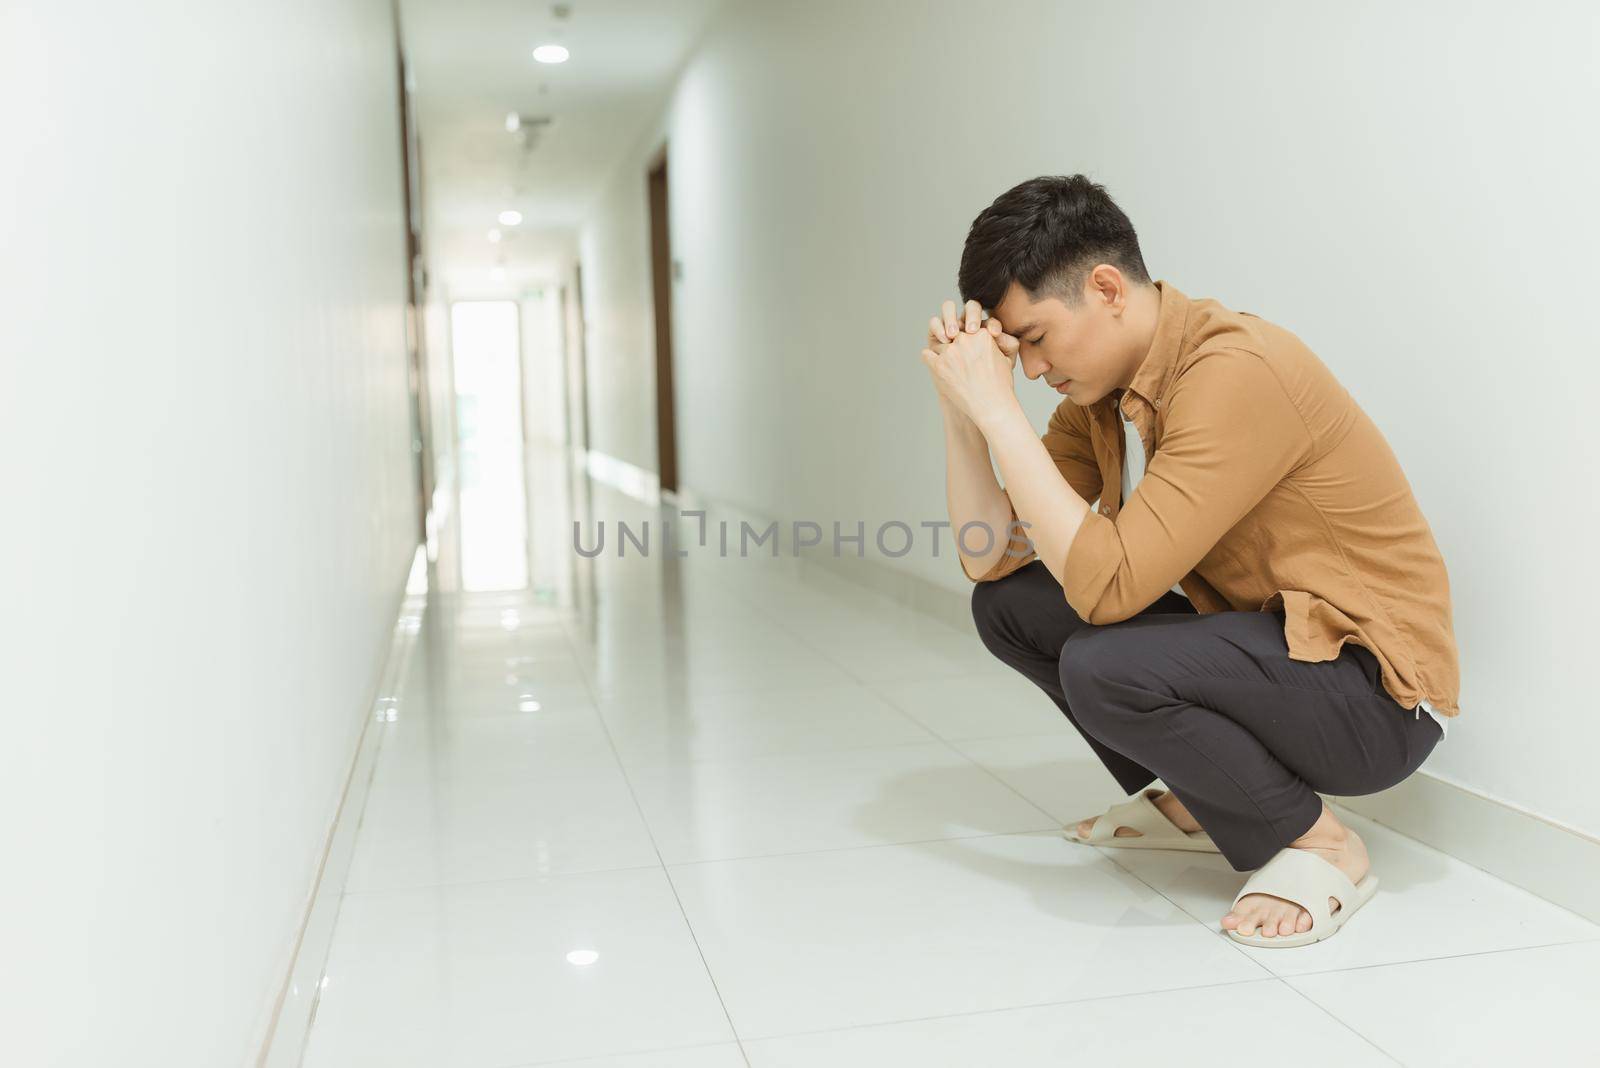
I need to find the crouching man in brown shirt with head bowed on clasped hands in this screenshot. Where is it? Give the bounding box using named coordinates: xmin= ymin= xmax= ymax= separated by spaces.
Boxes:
xmin=922 ymin=174 xmax=1459 ymax=946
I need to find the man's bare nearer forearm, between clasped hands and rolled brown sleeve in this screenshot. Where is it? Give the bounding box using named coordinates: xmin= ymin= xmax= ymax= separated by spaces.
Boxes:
xmin=952 ymin=408 xmax=1090 ymax=585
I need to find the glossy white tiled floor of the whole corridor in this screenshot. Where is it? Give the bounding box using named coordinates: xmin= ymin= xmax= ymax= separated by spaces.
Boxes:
xmin=304 ymin=476 xmax=1600 ymax=1068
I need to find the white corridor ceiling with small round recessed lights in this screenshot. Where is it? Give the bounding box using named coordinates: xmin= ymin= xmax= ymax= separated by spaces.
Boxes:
xmin=400 ymin=0 xmax=723 ymax=297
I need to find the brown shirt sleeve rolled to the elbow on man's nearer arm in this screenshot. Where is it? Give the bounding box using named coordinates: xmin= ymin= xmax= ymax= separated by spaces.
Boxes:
xmin=1062 ymin=350 xmax=1312 ymax=625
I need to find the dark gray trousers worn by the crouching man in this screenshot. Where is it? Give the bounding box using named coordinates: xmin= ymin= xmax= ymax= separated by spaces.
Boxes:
xmin=973 ymin=560 xmax=1442 ymax=871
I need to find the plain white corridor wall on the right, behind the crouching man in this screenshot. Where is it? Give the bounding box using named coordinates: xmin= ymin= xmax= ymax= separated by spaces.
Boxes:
xmin=581 ymin=0 xmax=1600 ymax=835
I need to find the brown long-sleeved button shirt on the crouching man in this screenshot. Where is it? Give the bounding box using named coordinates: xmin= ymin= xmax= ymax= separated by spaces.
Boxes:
xmin=978 ymin=281 xmax=1461 ymax=716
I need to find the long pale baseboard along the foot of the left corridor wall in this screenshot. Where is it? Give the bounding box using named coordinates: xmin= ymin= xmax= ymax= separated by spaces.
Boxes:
xmin=254 ymin=545 xmax=427 ymax=1068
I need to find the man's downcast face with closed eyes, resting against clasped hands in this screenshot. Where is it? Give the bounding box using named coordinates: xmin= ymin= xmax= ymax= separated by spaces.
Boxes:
xmin=990 ymin=280 xmax=1128 ymax=408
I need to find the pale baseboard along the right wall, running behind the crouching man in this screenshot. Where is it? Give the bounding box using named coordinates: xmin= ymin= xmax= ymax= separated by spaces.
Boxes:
xmin=587 ymin=454 xmax=1600 ymax=923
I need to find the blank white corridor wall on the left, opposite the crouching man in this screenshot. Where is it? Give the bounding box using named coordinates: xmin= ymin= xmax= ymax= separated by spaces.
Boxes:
xmin=0 ymin=0 xmax=416 ymax=1068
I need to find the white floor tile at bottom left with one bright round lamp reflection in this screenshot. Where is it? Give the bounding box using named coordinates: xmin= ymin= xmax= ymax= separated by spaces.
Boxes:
xmin=304 ymin=868 xmax=733 ymax=1068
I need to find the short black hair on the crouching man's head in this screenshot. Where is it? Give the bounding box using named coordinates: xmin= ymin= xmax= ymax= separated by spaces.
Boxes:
xmin=957 ymin=174 xmax=1150 ymax=310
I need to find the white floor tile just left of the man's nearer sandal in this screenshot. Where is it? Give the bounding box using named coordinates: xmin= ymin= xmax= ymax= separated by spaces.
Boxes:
xmin=669 ymin=835 xmax=1266 ymax=1038
